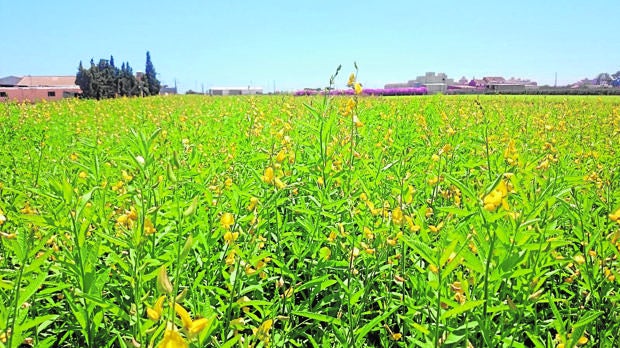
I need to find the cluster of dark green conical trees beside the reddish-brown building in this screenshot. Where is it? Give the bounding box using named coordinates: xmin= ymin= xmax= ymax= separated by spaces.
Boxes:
xmin=75 ymin=51 xmax=161 ymax=100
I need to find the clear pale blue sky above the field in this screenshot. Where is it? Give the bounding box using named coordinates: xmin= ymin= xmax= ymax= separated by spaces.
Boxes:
xmin=0 ymin=0 xmax=620 ymax=92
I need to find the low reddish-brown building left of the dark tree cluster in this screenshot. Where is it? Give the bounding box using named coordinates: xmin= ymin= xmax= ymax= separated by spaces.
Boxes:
xmin=0 ymin=76 xmax=82 ymax=102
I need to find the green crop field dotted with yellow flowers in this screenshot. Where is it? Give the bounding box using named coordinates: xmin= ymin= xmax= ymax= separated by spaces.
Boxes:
xmin=0 ymin=91 xmax=620 ymax=347
